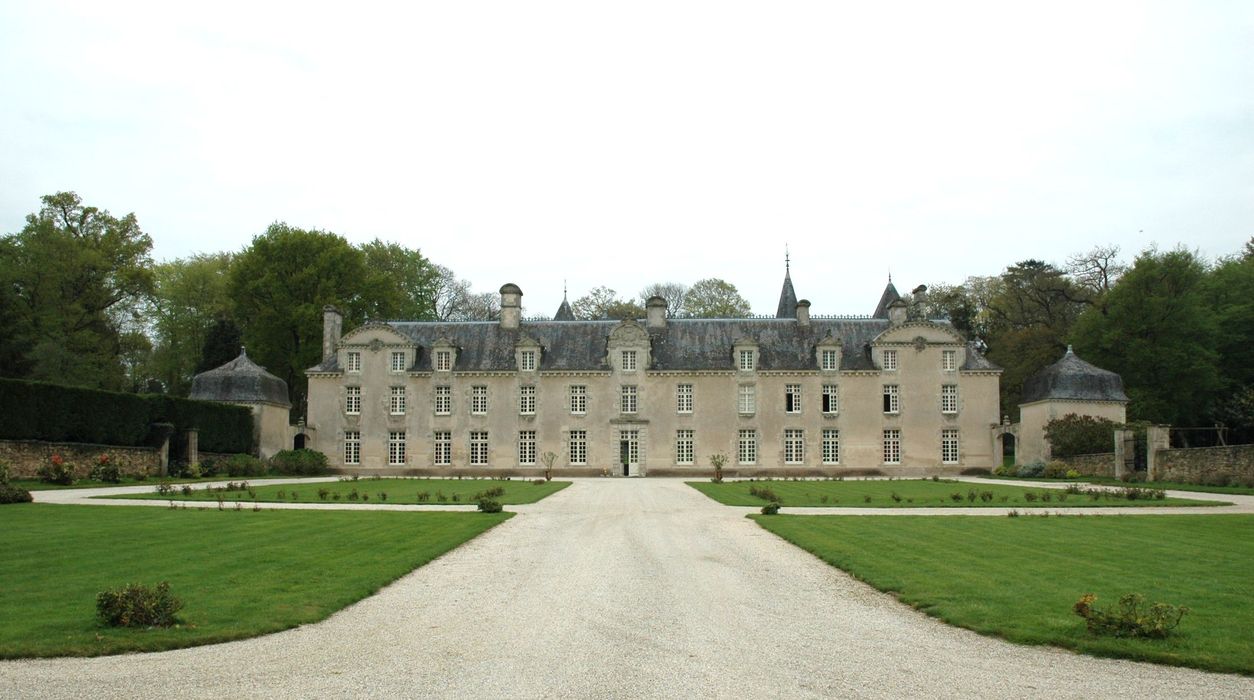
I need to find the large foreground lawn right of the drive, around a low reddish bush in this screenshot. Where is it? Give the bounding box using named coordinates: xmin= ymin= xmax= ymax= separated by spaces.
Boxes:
xmin=752 ymin=516 xmax=1254 ymax=675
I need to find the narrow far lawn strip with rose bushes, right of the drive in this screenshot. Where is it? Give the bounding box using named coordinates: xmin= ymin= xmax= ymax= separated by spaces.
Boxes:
xmin=687 ymin=479 xmax=1220 ymax=508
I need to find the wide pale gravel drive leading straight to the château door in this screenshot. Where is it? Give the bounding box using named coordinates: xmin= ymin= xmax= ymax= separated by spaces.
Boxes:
xmin=0 ymin=479 xmax=1254 ymax=699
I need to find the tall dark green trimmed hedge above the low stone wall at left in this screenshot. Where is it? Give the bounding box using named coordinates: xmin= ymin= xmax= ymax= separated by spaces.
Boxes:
xmin=0 ymin=379 xmax=252 ymax=454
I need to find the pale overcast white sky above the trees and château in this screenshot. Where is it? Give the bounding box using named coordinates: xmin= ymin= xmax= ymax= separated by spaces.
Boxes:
xmin=0 ymin=0 xmax=1254 ymax=315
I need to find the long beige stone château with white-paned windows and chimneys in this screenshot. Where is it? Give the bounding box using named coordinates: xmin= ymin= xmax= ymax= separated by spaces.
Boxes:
xmin=307 ymin=274 xmax=1001 ymax=475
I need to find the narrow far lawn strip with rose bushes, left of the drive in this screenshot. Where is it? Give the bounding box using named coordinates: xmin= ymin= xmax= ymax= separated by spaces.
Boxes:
xmin=108 ymin=478 xmax=571 ymax=506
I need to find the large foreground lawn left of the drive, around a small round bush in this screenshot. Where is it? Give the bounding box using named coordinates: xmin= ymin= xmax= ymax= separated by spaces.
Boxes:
xmin=0 ymin=503 xmax=512 ymax=657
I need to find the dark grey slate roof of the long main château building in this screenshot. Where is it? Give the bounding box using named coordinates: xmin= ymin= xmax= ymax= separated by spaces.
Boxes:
xmin=310 ymin=317 xmax=999 ymax=373
